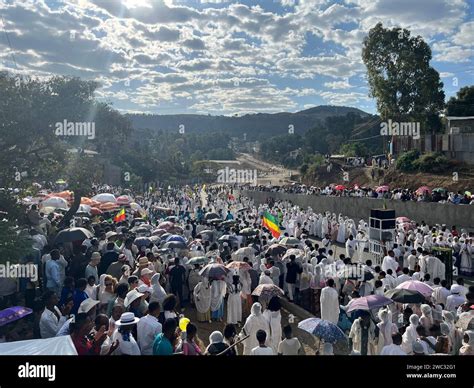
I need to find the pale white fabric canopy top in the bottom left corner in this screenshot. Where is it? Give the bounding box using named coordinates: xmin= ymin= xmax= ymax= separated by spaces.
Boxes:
xmin=0 ymin=335 xmax=77 ymax=356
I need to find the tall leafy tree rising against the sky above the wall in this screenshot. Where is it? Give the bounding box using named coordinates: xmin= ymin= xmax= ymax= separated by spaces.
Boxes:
xmin=362 ymin=23 xmax=445 ymax=132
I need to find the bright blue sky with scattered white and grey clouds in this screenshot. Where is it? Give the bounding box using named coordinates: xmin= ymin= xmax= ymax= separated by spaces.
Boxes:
xmin=0 ymin=0 xmax=474 ymax=115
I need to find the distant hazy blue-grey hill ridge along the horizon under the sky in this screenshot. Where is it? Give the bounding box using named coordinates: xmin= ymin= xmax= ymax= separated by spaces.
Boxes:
xmin=126 ymin=105 xmax=372 ymax=140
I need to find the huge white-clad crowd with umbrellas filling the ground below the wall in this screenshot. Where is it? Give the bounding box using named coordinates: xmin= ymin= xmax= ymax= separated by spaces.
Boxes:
xmin=0 ymin=183 xmax=474 ymax=355
